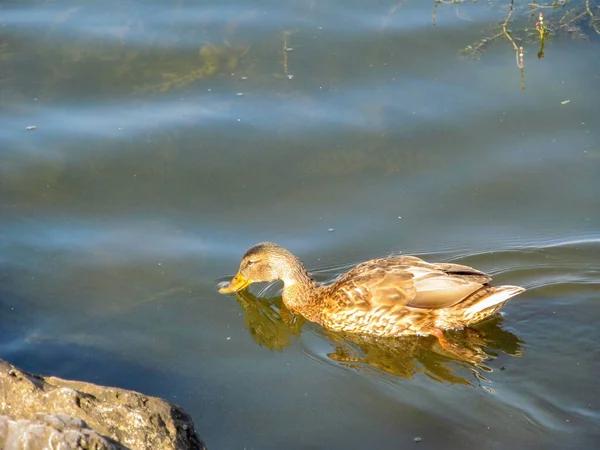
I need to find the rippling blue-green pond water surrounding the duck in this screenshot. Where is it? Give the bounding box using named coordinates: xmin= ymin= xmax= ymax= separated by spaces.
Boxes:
xmin=0 ymin=0 xmax=600 ymax=449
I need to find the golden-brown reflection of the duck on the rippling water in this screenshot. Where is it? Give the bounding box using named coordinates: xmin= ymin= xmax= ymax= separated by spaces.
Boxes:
xmin=236 ymin=290 xmax=523 ymax=385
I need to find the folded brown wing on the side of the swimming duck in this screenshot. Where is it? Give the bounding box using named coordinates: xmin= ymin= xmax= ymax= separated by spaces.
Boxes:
xmin=327 ymin=256 xmax=491 ymax=310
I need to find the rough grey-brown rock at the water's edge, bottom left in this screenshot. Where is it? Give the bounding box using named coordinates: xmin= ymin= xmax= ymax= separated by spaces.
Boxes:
xmin=0 ymin=360 xmax=206 ymax=450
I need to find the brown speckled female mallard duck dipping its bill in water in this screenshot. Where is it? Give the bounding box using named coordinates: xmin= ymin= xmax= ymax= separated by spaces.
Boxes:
xmin=219 ymin=242 xmax=525 ymax=345
